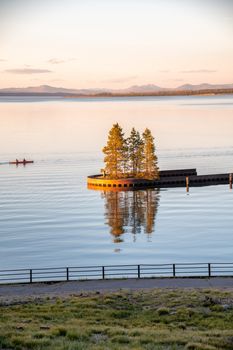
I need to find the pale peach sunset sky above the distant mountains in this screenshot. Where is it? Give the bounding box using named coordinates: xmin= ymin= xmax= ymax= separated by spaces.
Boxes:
xmin=0 ymin=0 xmax=233 ymax=89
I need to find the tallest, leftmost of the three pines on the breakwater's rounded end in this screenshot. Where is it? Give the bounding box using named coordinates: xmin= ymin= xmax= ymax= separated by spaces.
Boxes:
xmin=103 ymin=123 xmax=127 ymax=179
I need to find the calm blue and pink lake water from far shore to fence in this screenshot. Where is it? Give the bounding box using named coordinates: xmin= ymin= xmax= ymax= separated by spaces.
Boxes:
xmin=0 ymin=96 xmax=233 ymax=269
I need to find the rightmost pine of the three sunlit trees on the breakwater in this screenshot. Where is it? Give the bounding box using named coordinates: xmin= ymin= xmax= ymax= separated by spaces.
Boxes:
xmin=142 ymin=129 xmax=159 ymax=179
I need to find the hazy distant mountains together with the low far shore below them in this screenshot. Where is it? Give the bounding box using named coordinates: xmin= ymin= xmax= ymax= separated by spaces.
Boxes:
xmin=0 ymin=83 xmax=233 ymax=96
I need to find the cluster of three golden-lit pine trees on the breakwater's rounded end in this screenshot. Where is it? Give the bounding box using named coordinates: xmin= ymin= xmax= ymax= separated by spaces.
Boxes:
xmin=103 ymin=123 xmax=159 ymax=179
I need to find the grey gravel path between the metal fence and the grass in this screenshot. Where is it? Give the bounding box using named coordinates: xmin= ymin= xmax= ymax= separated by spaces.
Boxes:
xmin=0 ymin=277 xmax=233 ymax=303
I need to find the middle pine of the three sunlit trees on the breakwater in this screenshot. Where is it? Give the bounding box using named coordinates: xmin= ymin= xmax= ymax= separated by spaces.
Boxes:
xmin=127 ymin=128 xmax=143 ymax=177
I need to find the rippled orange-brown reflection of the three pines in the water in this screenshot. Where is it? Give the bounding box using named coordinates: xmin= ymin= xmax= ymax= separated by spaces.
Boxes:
xmin=102 ymin=189 xmax=159 ymax=243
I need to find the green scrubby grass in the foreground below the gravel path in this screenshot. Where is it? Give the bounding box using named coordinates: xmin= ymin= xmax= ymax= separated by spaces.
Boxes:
xmin=0 ymin=289 xmax=233 ymax=350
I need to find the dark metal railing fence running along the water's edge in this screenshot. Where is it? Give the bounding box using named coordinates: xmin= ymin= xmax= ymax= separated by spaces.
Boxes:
xmin=0 ymin=263 xmax=233 ymax=284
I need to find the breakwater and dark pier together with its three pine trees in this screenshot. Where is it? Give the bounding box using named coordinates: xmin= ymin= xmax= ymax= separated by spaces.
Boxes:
xmin=87 ymin=123 xmax=232 ymax=191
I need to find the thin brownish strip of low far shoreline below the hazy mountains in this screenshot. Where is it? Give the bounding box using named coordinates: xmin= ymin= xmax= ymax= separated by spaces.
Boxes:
xmin=0 ymin=89 xmax=233 ymax=98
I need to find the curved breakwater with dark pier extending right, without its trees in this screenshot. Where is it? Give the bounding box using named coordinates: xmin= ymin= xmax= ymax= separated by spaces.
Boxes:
xmin=87 ymin=169 xmax=232 ymax=190
